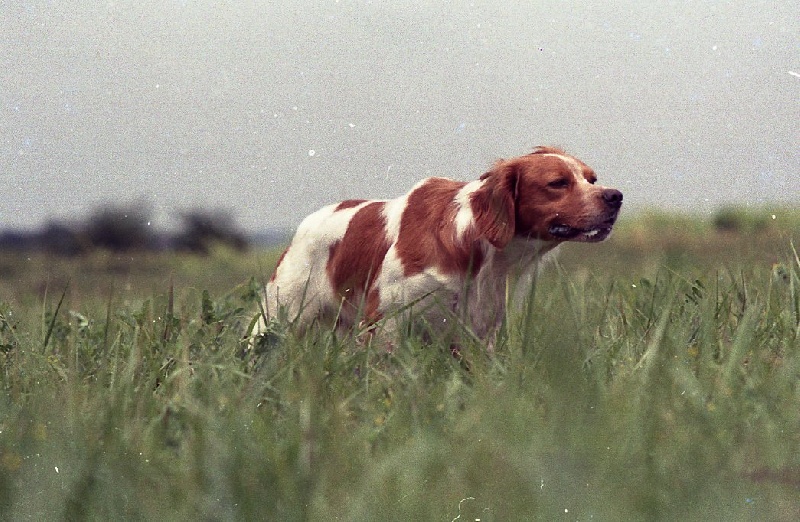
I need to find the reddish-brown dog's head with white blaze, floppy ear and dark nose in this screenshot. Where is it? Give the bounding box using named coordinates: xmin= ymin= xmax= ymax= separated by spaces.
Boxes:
xmin=472 ymin=147 xmax=622 ymax=248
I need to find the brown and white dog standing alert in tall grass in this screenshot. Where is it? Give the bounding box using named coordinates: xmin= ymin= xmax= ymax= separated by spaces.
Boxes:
xmin=252 ymin=147 xmax=622 ymax=346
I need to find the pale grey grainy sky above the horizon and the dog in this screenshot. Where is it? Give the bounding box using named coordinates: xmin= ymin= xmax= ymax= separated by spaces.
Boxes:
xmin=0 ymin=0 xmax=800 ymax=232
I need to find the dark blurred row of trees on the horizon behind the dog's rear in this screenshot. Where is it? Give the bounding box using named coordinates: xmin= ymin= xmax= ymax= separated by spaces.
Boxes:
xmin=0 ymin=205 xmax=249 ymax=255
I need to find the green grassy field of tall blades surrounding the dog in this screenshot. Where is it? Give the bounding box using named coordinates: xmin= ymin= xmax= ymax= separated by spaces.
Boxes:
xmin=0 ymin=210 xmax=800 ymax=522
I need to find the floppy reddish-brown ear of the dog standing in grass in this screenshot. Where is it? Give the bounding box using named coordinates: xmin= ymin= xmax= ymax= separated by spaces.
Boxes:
xmin=471 ymin=161 xmax=517 ymax=248
